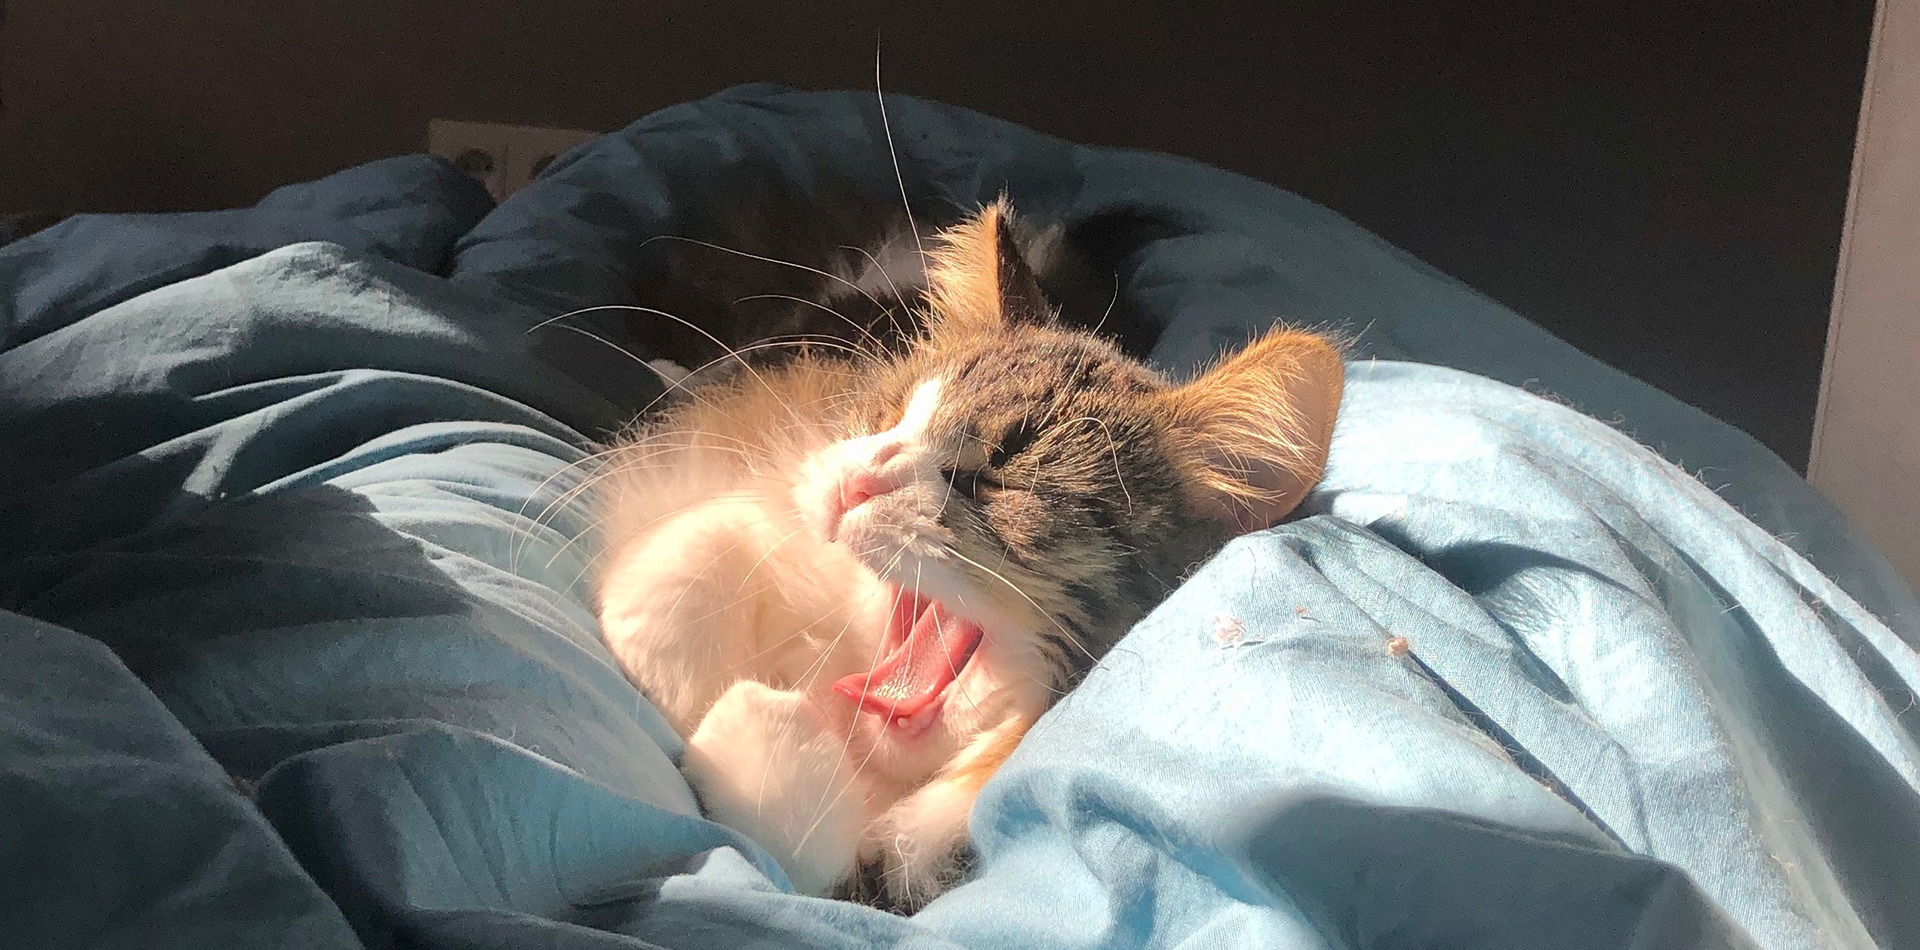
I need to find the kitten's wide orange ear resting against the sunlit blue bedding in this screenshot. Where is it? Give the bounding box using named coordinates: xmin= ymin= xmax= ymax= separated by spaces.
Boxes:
xmin=1162 ymin=330 xmax=1346 ymax=532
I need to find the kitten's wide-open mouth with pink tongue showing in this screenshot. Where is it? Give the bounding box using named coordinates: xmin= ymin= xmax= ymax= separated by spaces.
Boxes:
xmin=833 ymin=589 xmax=983 ymax=733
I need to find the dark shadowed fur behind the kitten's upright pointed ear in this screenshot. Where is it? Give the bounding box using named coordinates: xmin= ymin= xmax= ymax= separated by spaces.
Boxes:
xmin=632 ymin=184 xmax=1188 ymax=368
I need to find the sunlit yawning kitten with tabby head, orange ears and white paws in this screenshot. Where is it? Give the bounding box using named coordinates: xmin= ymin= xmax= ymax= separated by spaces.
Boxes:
xmin=597 ymin=202 xmax=1342 ymax=910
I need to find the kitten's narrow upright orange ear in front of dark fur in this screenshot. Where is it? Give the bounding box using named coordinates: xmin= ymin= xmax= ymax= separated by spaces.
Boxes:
xmin=927 ymin=198 xmax=1054 ymax=330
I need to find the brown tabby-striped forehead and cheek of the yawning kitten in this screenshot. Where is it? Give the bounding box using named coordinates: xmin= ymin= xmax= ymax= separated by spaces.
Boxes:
xmin=895 ymin=326 xmax=1217 ymax=670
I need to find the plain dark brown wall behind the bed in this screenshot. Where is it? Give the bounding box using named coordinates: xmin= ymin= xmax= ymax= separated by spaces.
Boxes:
xmin=0 ymin=0 xmax=1872 ymax=464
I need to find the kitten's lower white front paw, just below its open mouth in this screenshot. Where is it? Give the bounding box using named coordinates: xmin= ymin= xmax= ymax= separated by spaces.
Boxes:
xmin=682 ymin=679 xmax=866 ymax=894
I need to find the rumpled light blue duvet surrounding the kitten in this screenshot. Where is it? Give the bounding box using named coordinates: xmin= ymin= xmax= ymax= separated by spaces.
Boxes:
xmin=0 ymin=86 xmax=1920 ymax=948
